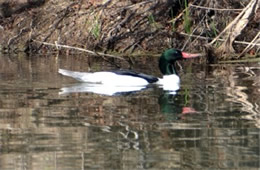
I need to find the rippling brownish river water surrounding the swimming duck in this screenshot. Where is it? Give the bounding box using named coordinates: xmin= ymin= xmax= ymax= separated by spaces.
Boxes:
xmin=0 ymin=52 xmax=260 ymax=170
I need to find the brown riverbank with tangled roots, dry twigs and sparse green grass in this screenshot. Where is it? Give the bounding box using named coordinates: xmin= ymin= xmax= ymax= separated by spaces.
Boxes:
xmin=0 ymin=0 xmax=260 ymax=63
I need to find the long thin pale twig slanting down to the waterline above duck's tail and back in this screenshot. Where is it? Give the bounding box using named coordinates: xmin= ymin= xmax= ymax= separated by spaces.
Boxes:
xmin=32 ymin=40 xmax=125 ymax=60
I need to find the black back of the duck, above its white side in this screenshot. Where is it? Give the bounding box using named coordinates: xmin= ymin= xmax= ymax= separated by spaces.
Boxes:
xmin=112 ymin=70 xmax=159 ymax=83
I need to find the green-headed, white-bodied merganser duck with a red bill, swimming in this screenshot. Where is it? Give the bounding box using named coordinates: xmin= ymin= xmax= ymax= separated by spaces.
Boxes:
xmin=59 ymin=49 xmax=201 ymax=95
